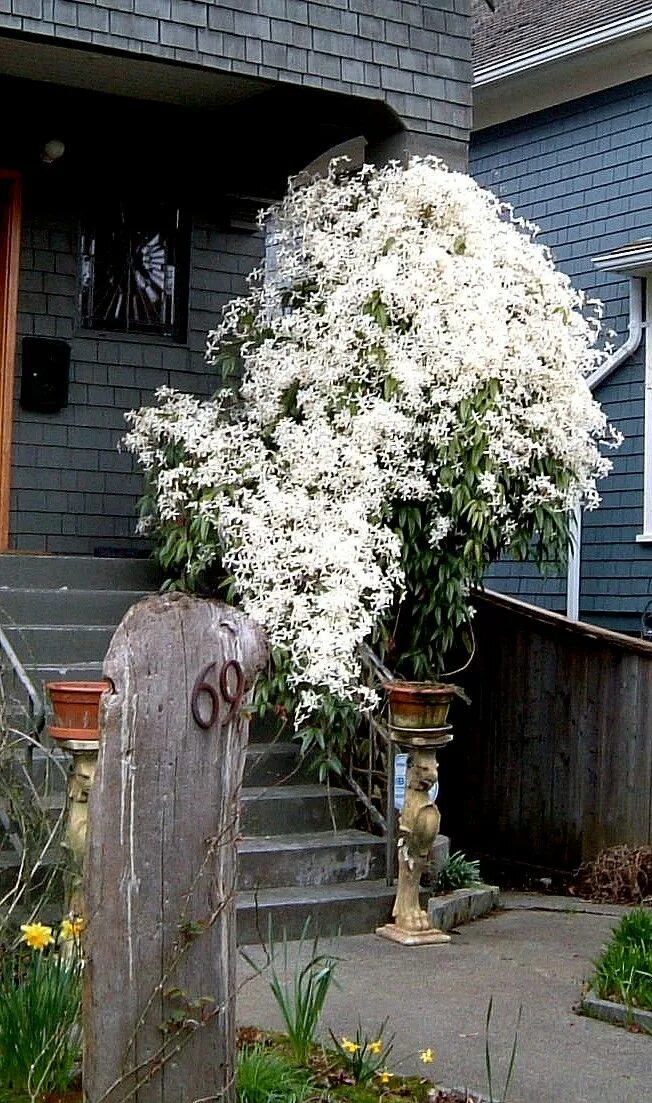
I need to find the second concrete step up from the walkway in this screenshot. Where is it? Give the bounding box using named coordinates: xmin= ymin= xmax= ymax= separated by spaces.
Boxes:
xmin=237 ymin=828 xmax=385 ymax=891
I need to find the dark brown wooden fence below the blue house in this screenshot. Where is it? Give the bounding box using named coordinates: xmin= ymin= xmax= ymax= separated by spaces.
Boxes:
xmin=439 ymin=592 xmax=652 ymax=870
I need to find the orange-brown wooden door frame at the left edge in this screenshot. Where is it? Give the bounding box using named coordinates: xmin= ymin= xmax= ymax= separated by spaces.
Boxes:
xmin=0 ymin=169 xmax=21 ymax=552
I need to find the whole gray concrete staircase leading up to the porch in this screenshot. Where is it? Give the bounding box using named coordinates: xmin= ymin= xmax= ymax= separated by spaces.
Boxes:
xmin=0 ymin=554 xmax=394 ymax=944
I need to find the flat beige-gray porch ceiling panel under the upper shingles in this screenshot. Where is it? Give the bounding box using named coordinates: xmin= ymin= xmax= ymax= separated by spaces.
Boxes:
xmin=0 ymin=36 xmax=270 ymax=108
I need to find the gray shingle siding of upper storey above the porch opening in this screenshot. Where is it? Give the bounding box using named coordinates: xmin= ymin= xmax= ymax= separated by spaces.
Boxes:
xmin=0 ymin=0 xmax=471 ymax=142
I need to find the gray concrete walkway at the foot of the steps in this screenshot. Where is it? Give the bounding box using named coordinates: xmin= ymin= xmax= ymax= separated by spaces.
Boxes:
xmin=237 ymin=893 xmax=652 ymax=1103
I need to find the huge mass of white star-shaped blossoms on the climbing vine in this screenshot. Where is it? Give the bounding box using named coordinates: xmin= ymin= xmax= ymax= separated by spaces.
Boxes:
xmin=127 ymin=159 xmax=614 ymax=721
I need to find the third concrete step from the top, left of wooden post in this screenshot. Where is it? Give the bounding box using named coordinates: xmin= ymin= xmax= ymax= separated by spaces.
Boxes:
xmin=4 ymin=624 xmax=116 ymax=665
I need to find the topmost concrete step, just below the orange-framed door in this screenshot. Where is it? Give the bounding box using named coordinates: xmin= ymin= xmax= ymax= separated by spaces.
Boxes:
xmin=0 ymin=552 xmax=161 ymax=590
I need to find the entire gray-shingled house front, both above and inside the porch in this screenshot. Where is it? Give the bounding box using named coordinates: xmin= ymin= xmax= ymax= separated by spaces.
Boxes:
xmin=0 ymin=0 xmax=471 ymax=553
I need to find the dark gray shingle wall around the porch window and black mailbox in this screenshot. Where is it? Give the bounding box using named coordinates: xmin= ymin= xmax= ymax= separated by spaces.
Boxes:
xmin=10 ymin=211 xmax=260 ymax=553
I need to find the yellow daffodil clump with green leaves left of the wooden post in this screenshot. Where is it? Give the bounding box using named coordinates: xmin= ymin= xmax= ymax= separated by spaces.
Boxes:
xmin=0 ymin=921 xmax=82 ymax=1101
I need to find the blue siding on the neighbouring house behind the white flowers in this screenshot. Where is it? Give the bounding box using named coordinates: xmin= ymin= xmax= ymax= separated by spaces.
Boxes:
xmin=470 ymin=78 xmax=652 ymax=632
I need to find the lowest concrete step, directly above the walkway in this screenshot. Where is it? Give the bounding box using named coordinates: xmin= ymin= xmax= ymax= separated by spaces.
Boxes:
xmin=237 ymin=880 xmax=396 ymax=946
